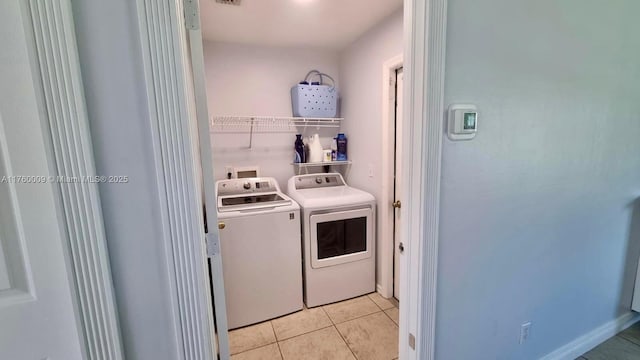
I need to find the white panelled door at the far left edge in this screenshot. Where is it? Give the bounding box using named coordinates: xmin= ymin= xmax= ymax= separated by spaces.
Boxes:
xmin=0 ymin=1 xmax=82 ymax=360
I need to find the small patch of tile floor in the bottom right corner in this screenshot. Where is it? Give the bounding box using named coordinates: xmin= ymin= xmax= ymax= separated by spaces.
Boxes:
xmin=576 ymin=323 xmax=640 ymax=360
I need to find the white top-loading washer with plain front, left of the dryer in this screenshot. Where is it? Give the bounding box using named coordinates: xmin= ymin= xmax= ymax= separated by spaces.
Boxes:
xmin=216 ymin=177 xmax=303 ymax=329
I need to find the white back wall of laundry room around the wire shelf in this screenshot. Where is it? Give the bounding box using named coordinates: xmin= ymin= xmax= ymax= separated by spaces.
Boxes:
xmin=204 ymin=42 xmax=339 ymax=190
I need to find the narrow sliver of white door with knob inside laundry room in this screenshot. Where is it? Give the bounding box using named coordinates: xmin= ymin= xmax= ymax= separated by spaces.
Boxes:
xmin=393 ymin=68 xmax=404 ymax=300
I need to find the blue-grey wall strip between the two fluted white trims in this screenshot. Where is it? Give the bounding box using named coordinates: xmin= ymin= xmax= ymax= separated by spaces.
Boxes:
xmin=72 ymin=0 xmax=181 ymax=360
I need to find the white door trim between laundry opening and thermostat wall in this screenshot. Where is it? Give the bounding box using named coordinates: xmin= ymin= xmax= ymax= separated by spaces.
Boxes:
xmin=400 ymin=0 xmax=447 ymax=360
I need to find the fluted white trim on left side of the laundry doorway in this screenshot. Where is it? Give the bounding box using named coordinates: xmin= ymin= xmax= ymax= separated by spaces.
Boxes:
xmin=136 ymin=0 xmax=215 ymax=359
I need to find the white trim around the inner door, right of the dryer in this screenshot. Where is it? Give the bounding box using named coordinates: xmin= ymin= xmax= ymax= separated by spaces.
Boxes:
xmin=377 ymin=54 xmax=403 ymax=298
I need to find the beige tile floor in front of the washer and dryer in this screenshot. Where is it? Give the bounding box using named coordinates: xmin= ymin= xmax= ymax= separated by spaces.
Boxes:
xmin=229 ymin=293 xmax=398 ymax=360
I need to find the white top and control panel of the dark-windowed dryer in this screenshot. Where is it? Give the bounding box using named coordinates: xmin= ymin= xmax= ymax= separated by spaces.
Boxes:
xmin=288 ymin=174 xmax=375 ymax=209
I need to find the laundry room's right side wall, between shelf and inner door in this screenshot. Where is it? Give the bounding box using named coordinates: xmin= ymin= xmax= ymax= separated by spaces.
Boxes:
xmin=340 ymin=10 xmax=403 ymax=288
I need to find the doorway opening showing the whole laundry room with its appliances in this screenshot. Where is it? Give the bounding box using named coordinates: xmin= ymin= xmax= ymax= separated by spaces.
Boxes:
xmin=200 ymin=0 xmax=405 ymax=359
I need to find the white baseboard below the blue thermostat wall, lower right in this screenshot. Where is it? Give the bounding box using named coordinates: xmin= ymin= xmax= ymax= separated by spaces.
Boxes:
xmin=541 ymin=311 xmax=640 ymax=360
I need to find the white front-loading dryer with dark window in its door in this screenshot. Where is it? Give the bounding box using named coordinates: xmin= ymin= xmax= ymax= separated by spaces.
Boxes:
xmin=287 ymin=173 xmax=376 ymax=307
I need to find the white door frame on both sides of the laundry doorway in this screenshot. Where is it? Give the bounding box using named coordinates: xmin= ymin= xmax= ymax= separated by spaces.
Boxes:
xmin=136 ymin=0 xmax=447 ymax=360
